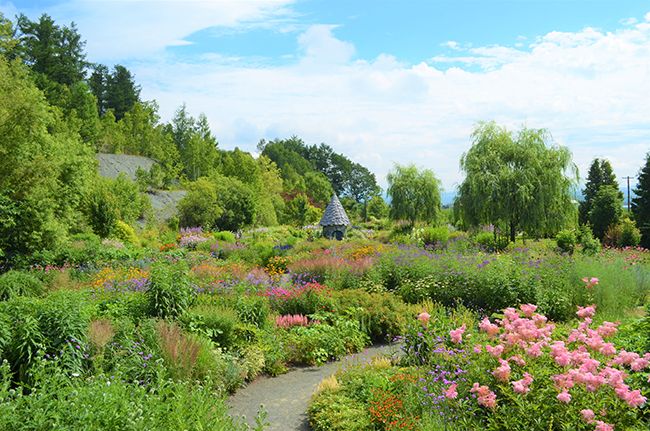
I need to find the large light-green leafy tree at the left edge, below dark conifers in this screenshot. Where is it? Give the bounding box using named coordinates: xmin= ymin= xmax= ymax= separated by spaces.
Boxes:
xmin=0 ymin=56 xmax=96 ymax=259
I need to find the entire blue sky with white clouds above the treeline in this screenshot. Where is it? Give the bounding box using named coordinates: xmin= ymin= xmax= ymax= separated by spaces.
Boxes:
xmin=0 ymin=0 xmax=650 ymax=190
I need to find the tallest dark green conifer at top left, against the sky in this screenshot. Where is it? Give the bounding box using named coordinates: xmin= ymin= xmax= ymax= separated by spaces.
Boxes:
xmin=17 ymin=14 xmax=87 ymax=88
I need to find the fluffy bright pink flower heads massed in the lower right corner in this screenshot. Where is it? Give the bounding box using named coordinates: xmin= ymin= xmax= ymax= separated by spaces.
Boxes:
xmin=466 ymin=304 xmax=650 ymax=431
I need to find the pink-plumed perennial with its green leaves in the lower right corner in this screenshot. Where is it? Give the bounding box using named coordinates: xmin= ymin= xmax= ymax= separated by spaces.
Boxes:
xmin=456 ymin=306 xmax=650 ymax=430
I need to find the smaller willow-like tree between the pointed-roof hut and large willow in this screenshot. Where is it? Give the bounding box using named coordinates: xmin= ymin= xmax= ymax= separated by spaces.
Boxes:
xmin=387 ymin=165 xmax=440 ymax=225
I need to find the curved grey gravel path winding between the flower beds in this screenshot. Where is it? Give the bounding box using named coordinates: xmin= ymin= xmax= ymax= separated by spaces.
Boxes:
xmin=228 ymin=344 xmax=399 ymax=431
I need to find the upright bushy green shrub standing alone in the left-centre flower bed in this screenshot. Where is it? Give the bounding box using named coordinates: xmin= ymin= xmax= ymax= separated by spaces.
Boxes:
xmin=146 ymin=263 xmax=195 ymax=318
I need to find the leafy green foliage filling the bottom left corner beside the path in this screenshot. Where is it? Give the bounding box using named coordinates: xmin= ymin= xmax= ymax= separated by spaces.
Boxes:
xmin=0 ymin=364 xmax=247 ymax=431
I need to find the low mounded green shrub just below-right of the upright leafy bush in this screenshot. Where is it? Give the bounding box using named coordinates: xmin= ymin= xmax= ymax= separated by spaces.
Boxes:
xmin=181 ymin=305 xmax=238 ymax=349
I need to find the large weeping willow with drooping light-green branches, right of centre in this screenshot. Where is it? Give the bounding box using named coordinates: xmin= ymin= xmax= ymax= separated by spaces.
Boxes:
xmin=455 ymin=122 xmax=578 ymax=241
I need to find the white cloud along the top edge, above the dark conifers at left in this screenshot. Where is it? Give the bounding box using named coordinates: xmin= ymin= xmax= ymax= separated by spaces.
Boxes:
xmin=8 ymin=0 xmax=292 ymax=62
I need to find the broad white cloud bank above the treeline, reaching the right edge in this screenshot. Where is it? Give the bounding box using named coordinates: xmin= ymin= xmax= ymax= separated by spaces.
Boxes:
xmin=134 ymin=16 xmax=650 ymax=190
